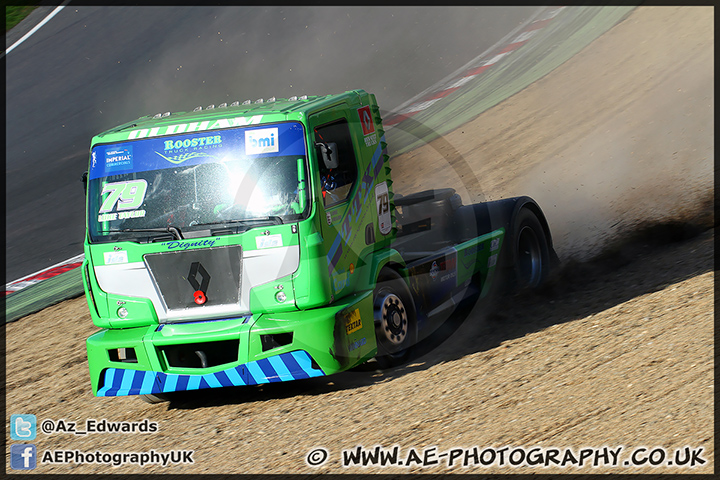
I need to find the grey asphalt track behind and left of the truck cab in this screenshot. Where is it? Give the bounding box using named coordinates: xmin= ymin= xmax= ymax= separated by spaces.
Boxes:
xmin=4 ymin=3 xmax=536 ymax=280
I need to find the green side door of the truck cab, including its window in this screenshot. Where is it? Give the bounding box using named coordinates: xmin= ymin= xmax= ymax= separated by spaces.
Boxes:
xmin=310 ymin=107 xmax=365 ymax=299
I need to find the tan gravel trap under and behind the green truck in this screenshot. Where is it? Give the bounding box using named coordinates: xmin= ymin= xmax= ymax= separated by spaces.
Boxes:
xmin=6 ymin=7 xmax=714 ymax=473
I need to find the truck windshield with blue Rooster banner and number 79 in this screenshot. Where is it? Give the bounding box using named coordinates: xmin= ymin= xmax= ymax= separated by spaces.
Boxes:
xmin=88 ymin=122 xmax=309 ymax=242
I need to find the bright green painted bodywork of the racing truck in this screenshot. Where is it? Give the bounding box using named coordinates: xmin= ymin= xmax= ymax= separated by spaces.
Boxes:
xmin=83 ymin=90 xmax=504 ymax=393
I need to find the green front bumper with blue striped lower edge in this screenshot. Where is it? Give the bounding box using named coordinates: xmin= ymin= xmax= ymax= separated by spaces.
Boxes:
xmin=87 ymin=292 xmax=376 ymax=396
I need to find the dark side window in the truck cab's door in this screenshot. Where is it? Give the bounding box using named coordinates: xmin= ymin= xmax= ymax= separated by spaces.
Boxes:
xmin=315 ymin=119 xmax=357 ymax=206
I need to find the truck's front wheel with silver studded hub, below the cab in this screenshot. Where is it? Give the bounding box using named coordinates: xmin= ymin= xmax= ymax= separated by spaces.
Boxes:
xmin=373 ymin=268 xmax=417 ymax=368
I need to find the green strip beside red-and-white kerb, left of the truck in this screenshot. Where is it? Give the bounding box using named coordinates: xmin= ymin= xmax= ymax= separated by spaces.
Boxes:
xmin=5 ymin=267 xmax=84 ymax=322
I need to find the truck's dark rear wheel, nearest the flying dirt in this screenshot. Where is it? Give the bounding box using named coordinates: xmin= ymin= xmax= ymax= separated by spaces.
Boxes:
xmin=509 ymin=208 xmax=552 ymax=290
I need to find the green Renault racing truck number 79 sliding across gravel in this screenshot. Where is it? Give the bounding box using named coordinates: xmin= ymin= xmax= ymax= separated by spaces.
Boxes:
xmin=82 ymin=90 xmax=556 ymax=402
